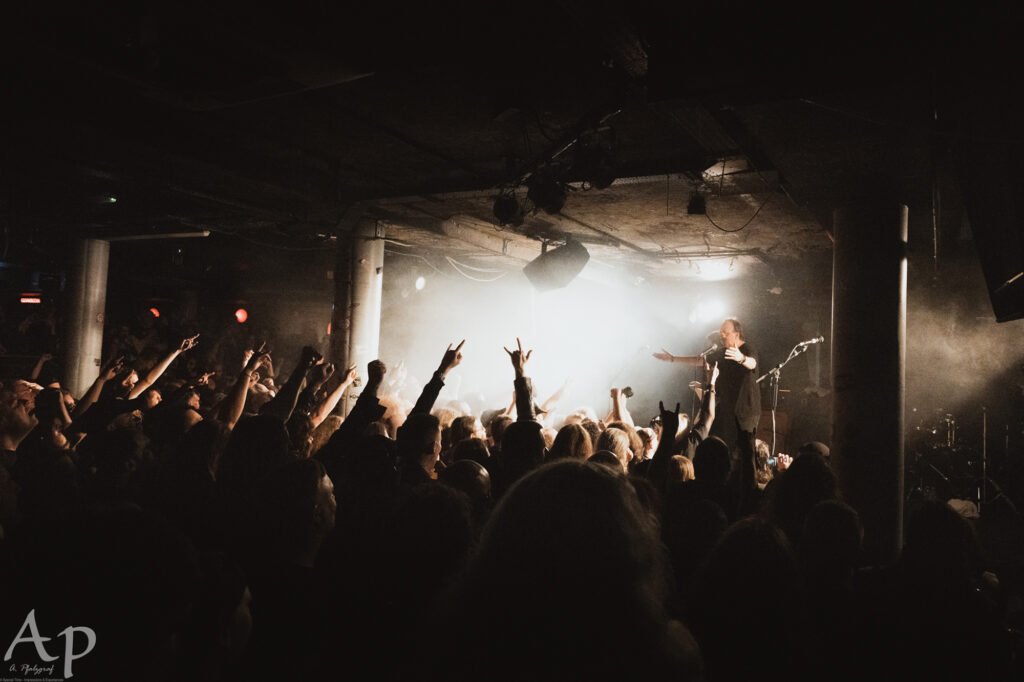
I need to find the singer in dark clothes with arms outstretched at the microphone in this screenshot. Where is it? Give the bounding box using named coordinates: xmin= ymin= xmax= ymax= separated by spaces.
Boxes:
xmin=653 ymin=317 xmax=761 ymax=449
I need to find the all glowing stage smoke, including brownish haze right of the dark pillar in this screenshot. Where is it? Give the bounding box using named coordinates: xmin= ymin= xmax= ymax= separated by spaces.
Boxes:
xmin=370 ymin=246 xmax=1024 ymax=444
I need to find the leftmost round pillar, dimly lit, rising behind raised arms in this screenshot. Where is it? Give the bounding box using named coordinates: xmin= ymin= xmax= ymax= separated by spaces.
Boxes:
xmin=65 ymin=240 xmax=111 ymax=397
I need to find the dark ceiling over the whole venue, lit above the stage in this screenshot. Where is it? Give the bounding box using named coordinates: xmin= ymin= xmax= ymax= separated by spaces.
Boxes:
xmin=0 ymin=0 xmax=1019 ymax=292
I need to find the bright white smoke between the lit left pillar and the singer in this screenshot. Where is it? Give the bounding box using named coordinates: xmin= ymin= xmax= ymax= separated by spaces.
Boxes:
xmin=380 ymin=259 xmax=720 ymax=424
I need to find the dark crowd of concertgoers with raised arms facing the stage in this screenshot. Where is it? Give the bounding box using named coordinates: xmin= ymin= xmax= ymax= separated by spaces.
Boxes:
xmin=0 ymin=311 xmax=1024 ymax=681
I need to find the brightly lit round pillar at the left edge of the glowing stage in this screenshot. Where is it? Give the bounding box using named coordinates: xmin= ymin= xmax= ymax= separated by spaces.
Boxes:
xmin=331 ymin=218 xmax=384 ymax=415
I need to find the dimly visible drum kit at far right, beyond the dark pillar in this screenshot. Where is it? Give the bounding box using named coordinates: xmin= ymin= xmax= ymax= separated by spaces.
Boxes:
xmin=905 ymin=409 xmax=986 ymax=502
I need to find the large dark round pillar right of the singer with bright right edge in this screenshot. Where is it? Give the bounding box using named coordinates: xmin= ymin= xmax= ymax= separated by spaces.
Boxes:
xmin=831 ymin=200 xmax=907 ymax=563
